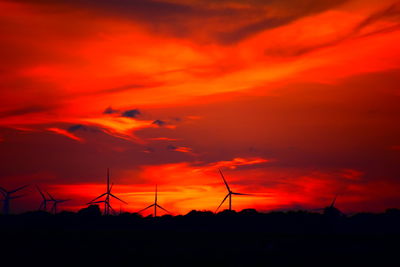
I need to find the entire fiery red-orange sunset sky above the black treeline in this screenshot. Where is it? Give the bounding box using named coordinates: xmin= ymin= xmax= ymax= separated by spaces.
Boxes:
xmin=0 ymin=0 xmax=400 ymax=214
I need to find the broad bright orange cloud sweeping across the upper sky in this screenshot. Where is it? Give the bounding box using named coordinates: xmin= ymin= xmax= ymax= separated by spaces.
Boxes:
xmin=2 ymin=1 xmax=400 ymax=123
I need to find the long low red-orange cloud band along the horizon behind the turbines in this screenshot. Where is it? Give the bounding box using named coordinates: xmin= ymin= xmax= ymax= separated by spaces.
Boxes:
xmin=30 ymin=161 xmax=399 ymax=215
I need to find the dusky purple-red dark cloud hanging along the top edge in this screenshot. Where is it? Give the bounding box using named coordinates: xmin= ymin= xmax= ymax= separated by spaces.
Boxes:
xmin=14 ymin=0 xmax=348 ymax=44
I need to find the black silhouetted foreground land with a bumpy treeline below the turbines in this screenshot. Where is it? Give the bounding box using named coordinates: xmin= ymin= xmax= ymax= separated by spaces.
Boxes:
xmin=0 ymin=210 xmax=400 ymax=266
